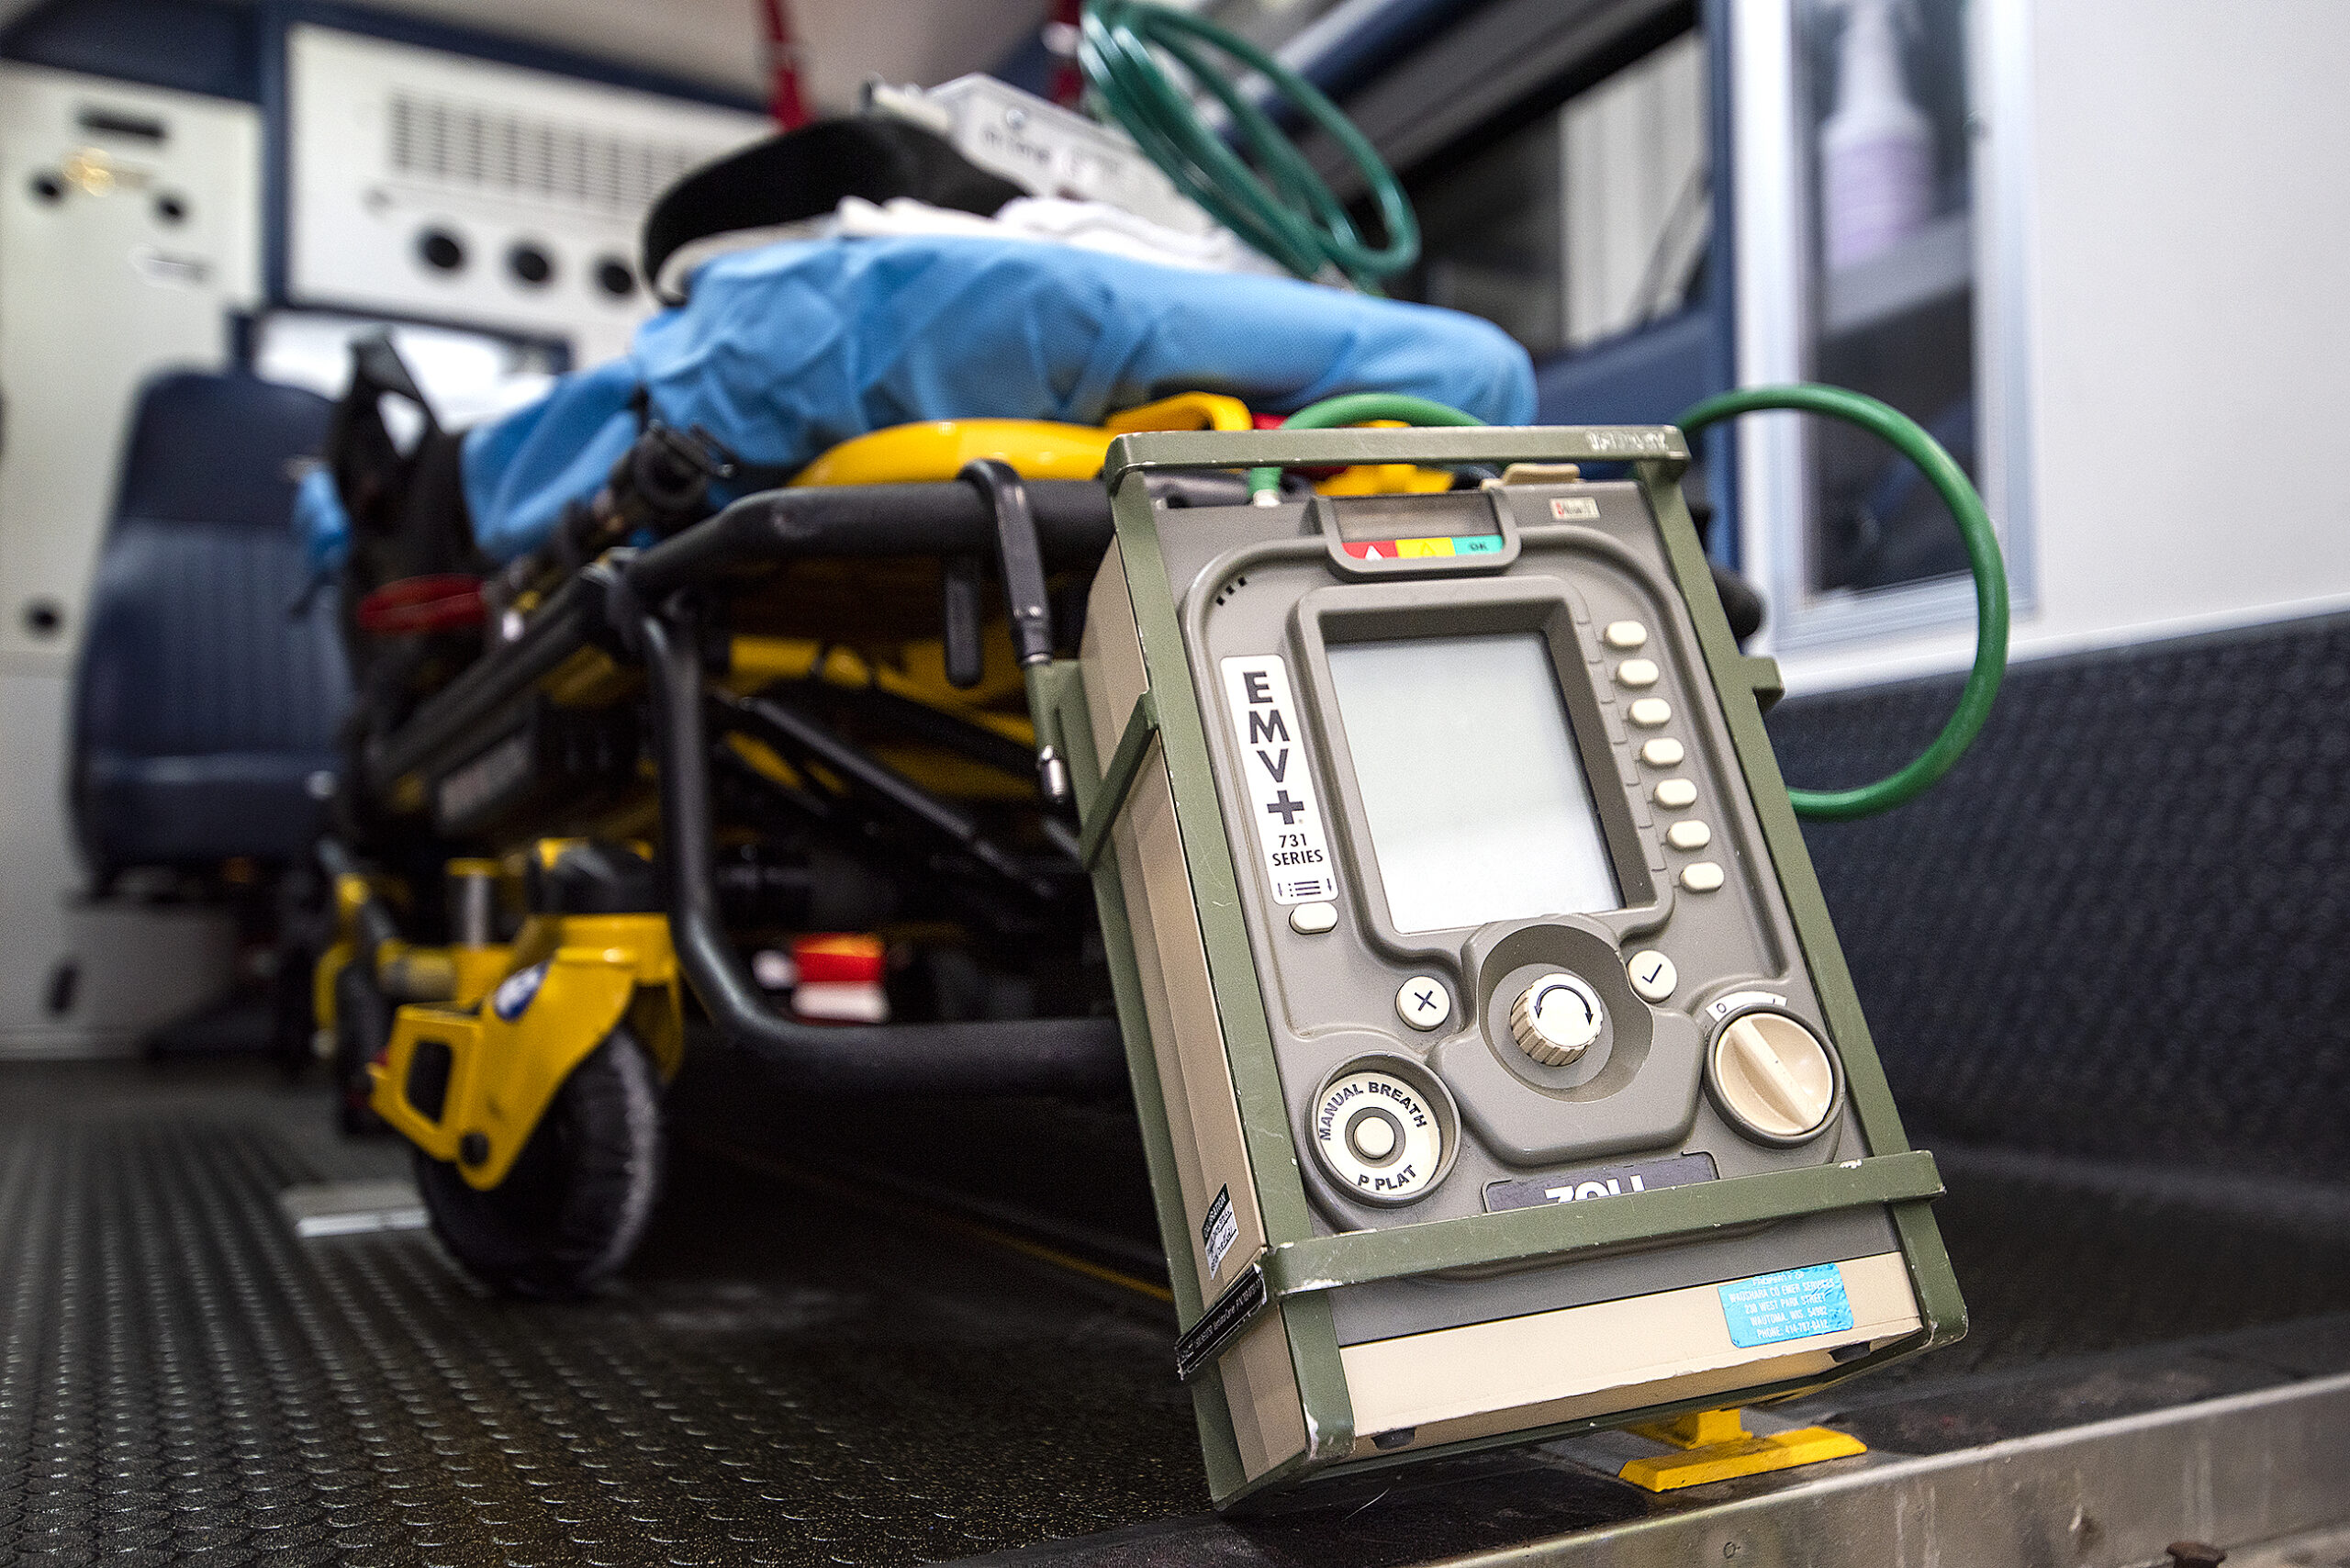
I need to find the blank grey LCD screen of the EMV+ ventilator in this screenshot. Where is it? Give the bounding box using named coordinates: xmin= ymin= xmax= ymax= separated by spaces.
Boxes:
xmin=1330 ymin=633 xmax=1624 ymax=931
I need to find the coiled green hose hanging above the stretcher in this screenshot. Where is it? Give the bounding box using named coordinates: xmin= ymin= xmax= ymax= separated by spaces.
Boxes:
xmin=1076 ymin=0 xmax=1419 ymax=294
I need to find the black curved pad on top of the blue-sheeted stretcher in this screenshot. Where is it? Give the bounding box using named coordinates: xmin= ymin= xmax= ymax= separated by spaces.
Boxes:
xmin=643 ymin=115 xmax=1027 ymax=306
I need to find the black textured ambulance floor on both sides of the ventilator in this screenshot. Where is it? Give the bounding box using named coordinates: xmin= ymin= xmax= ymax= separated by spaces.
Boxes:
xmin=0 ymin=1058 xmax=2350 ymax=1568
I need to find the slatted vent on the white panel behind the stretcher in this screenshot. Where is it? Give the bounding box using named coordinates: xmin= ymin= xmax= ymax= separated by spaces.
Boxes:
xmin=387 ymin=87 xmax=710 ymax=218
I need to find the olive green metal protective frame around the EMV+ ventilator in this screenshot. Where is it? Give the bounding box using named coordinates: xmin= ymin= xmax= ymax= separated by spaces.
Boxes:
xmin=1032 ymin=425 xmax=1967 ymax=1506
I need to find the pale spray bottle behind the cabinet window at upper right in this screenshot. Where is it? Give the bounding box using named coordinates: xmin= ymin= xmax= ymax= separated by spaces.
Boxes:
xmin=1818 ymin=0 xmax=1934 ymax=268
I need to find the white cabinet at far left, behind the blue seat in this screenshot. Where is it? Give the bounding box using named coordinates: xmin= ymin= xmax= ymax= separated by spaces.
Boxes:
xmin=0 ymin=63 xmax=261 ymax=1056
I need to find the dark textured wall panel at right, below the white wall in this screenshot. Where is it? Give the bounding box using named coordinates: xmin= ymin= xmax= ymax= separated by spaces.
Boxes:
xmin=1772 ymin=618 xmax=2350 ymax=1178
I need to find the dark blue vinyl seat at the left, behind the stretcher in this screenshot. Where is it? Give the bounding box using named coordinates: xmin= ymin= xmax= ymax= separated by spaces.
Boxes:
xmin=73 ymin=374 xmax=350 ymax=891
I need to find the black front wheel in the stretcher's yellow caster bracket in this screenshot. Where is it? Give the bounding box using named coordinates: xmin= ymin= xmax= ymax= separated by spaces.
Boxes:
xmin=416 ymin=1027 xmax=663 ymax=1298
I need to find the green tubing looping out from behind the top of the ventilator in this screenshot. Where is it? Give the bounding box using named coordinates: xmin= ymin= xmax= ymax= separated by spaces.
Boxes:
xmin=1248 ymin=386 xmax=2007 ymax=823
